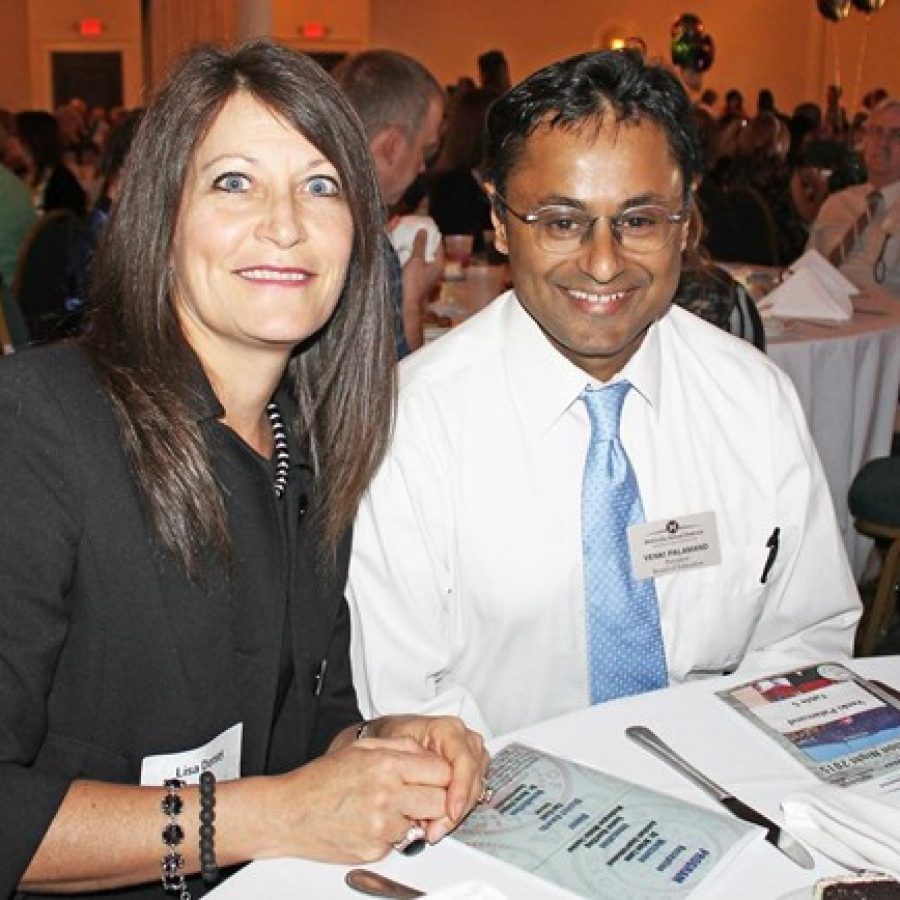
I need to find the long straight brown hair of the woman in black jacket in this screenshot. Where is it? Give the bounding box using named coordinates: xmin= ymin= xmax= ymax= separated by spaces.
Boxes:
xmin=83 ymin=40 xmax=395 ymax=577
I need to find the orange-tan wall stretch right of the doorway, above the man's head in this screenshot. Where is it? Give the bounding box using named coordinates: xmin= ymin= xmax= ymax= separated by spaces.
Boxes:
xmin=371 ymin=0 xmax=900 ymax=112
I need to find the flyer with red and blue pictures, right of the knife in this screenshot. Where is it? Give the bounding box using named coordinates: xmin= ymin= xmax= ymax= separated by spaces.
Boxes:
xmin=719 ymin=662 xmax=900 ymax=805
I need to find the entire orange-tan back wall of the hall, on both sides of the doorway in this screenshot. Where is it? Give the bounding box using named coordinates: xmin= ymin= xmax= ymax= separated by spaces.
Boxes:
xmin=0 ymin=0 xmax=900 ymax=112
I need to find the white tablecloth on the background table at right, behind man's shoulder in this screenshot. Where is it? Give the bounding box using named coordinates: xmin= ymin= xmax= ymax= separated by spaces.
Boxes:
xmin=768 ymin=295 xmax=900 ymax=578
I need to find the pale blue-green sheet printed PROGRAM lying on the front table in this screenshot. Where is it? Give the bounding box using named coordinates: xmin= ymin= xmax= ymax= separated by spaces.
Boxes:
xmin=453 ymin=744 xmax=762 ymax=900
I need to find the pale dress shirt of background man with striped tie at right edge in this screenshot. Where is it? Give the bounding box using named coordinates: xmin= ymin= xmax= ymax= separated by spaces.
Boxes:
xmin=806 ymin=181 xmax=900 ymax=296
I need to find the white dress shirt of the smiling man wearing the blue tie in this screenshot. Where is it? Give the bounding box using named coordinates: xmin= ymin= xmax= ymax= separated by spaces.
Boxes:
xmin=348 ymin=292 xmax=860 ymax=735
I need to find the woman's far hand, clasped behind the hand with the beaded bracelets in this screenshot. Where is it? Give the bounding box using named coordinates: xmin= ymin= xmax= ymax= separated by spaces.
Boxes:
xmin=362 ymin=716 xmax=490 ymax=844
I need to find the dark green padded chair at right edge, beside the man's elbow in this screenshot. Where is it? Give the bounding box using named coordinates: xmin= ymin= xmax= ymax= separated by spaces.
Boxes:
xmin=848 ymin=456 xmax=900 ymax=656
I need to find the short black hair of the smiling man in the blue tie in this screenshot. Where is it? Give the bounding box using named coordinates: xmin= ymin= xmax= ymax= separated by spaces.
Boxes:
xmin=485 ymin=50 xmax=701 ymax=198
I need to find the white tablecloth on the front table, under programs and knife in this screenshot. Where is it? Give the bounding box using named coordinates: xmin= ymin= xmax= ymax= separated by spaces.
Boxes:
xmin=204 ymin=656 xmax=900 ymax=900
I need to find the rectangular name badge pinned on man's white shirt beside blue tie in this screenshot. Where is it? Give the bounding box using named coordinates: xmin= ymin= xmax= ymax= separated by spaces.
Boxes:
xmin=628 ymin=512 xmax=721 ymax=580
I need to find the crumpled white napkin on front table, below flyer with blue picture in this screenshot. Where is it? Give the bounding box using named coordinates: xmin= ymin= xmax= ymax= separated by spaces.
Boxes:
xmin=781 ymin=784 xmax=900 ymax=879
